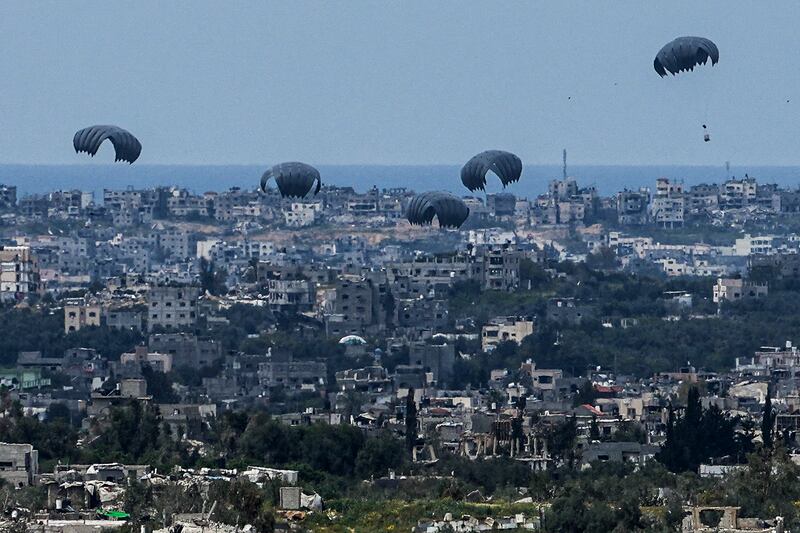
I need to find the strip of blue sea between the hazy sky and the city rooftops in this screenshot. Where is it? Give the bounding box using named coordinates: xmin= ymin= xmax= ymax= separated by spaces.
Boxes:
xmin=0 ymin=164 xmax=800 ymax=199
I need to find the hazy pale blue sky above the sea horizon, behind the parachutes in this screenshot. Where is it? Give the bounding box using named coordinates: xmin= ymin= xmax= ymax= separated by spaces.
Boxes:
xmin=0 ymin=0 xmax=800 ymax=165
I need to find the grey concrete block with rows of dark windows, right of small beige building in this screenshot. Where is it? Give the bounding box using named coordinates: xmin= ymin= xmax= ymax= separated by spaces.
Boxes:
xmin=147 ymin=286 xmax=200 ymax=331
